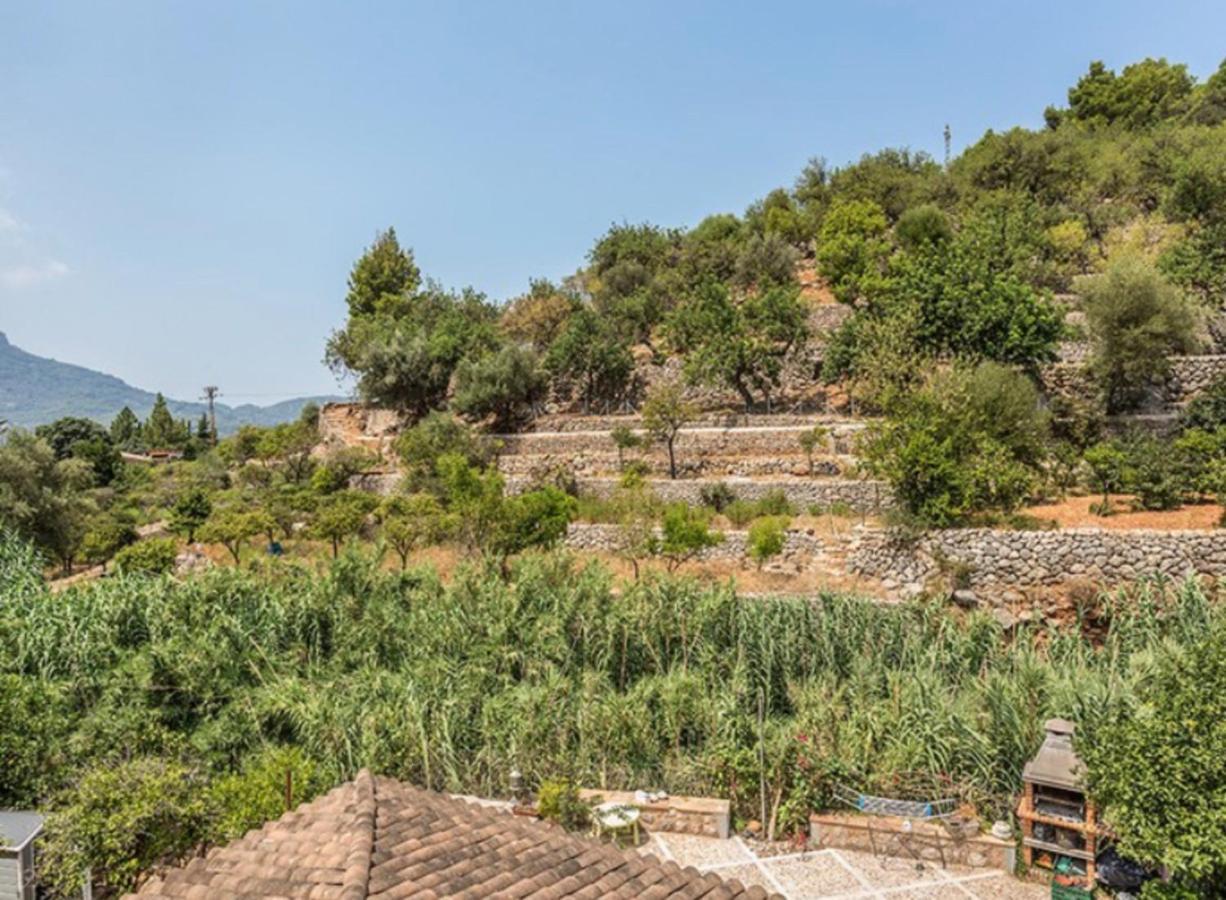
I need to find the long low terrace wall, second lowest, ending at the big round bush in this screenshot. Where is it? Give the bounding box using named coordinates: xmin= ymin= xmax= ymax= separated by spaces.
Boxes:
xmin=506 ymin=477 xmax=893 ymax=514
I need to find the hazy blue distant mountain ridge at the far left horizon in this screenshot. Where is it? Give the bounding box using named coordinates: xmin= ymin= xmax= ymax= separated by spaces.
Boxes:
xmin=0 ymin=331 xmax=343 ymax=434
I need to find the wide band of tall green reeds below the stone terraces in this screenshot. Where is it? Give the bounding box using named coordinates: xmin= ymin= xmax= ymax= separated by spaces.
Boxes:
xmin=0 ymin=532 xmax=1221 ymax=828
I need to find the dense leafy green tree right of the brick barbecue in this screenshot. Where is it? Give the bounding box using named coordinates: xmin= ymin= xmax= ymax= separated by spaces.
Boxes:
xmin=1078 ymin=624 xmax=1226 ymax=896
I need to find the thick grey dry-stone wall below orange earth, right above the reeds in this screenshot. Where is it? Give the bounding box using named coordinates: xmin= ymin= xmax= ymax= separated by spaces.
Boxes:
xmin=847 ymin=528 xmax=1226 ymax=592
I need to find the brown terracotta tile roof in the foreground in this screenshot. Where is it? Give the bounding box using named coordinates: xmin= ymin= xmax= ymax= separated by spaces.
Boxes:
xmin=129 ymin=770 xmax=767 ymax=900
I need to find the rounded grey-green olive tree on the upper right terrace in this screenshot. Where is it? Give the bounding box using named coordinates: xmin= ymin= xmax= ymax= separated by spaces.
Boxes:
xmin=1078 ymin=257 xmax=1200 ymax=412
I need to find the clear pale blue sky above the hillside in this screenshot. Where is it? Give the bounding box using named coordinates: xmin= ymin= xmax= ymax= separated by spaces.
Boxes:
xmin=0 ymin=0 xmax=1226 ymax=402
